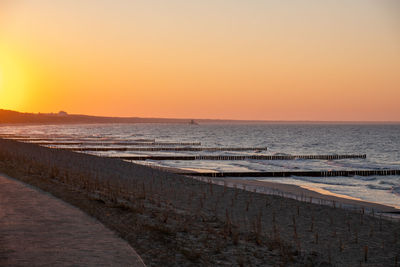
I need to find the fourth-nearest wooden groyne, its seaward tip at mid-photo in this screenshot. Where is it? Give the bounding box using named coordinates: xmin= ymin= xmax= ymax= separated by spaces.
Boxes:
xmin=30 ymin=141 xmax=201 ymax=146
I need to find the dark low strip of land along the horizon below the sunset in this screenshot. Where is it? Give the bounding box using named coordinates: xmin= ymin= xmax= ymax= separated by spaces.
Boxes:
xmin=0 ymin=109 xmax=400 ymax=124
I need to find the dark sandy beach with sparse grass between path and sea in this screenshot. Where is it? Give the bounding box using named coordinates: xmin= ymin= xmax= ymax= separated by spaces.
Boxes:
xmin=0 ymin=140 xmax=400 ymax=266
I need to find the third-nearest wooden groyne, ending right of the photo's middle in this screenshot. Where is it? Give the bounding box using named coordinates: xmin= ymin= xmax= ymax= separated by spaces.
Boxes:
xmin=63 ymin=147 xmax=267 ymax=151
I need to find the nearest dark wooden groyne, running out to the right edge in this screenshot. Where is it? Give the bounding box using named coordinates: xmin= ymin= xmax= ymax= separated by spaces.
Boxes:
xmin=179 ymin=170 xmax=400 ymax=177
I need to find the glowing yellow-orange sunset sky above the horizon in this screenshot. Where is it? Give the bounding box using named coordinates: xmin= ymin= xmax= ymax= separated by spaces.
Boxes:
xmin=0 ymin=0 xmax=400 ymax=121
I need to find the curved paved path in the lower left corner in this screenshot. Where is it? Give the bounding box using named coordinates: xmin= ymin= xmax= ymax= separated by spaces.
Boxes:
xmin=0 ymin=174 xmax=144 ymax=266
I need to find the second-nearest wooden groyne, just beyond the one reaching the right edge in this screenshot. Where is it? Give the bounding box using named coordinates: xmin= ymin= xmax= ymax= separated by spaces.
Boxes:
xmin=116 ymin=154 xmax=367 ymax=161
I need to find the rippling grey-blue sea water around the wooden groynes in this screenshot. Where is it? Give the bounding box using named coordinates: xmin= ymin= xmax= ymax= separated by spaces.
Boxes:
xmin=0 ymin=124 xmax=400 ymax=209
